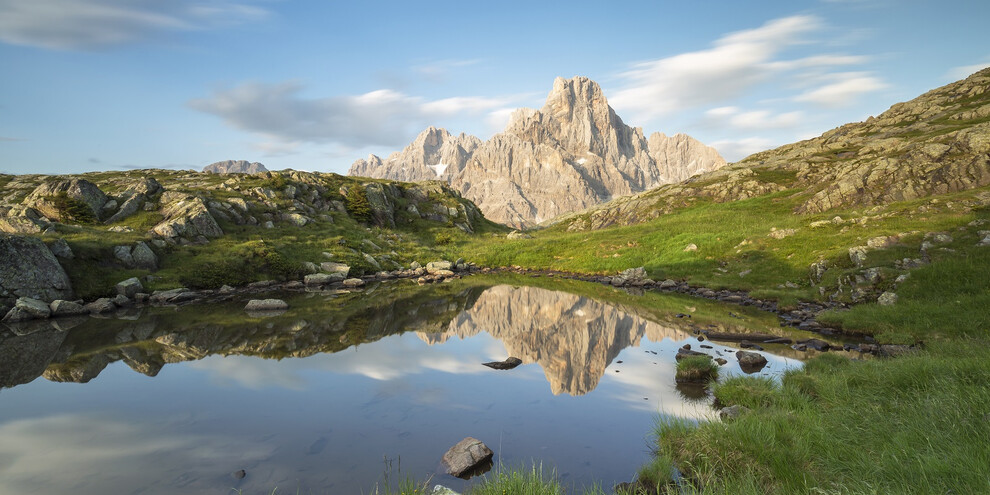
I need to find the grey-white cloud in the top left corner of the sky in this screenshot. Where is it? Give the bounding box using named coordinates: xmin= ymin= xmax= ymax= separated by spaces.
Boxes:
xmin=0 ymin=0 xmax=268 ymax=50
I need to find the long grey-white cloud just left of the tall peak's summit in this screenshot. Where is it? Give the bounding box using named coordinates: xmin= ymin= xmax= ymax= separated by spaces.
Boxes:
xmin=188 ymin=82 xmax=524 ymax=149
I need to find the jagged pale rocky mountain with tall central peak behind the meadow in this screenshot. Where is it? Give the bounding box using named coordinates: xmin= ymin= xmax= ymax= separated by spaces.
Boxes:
xmin=349 ymin=77 xmax=725 ymax=227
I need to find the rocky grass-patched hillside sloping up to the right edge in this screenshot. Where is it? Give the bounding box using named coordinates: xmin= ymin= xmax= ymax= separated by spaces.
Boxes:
xmin=557 ymin=69 xmax=990 ymax=230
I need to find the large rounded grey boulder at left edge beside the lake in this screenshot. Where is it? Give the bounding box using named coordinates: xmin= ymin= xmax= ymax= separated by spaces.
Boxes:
xmin=0 ymin=234 xmax=73 ymax=305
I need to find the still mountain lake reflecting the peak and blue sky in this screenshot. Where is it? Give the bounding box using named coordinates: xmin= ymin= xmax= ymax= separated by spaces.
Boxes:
xmin=0 ymin=277 xmax=828 ymax=495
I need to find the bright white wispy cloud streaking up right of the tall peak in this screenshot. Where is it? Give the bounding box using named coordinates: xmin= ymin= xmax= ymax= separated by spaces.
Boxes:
xmin=610 ymin=15 xmax=885 ymax=119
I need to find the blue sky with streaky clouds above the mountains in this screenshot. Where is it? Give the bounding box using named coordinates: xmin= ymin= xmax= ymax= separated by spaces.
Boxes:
xmin=0 ymin=0 xmax=990 ymax=174
